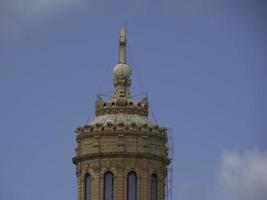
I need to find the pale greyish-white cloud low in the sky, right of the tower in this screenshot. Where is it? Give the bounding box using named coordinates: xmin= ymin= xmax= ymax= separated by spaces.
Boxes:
xmin=213 ymin=151 xmax=267 ymax=200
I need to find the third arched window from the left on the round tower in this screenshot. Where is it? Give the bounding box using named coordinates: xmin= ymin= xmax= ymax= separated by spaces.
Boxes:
xmin=127 ymin=172 xmax=137 ymax=200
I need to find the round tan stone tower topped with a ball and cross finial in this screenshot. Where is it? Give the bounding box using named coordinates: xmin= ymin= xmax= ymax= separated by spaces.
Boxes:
xmin=73 ymin=28 xmax=169 ymax=200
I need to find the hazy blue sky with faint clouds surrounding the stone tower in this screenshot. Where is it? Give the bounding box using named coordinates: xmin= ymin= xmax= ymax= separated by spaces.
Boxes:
xmin=0 ymin=0 xmax=267 ymax=200
